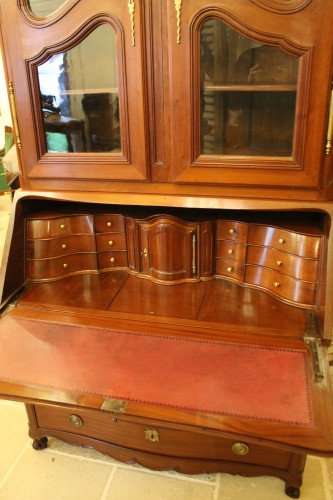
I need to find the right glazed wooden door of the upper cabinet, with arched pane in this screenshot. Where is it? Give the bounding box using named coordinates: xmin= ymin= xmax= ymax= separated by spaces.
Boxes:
xmin=170 ymin=0 xmax=333 ymax=198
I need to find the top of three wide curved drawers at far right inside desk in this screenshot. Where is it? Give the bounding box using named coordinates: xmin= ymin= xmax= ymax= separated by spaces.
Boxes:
xmin=248 ymin=224 xmax=321 ymax=259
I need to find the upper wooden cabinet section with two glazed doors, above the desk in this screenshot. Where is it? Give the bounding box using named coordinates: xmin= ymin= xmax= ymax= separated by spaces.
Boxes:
xmin=2 ymin=0 xmax=333 ymax=200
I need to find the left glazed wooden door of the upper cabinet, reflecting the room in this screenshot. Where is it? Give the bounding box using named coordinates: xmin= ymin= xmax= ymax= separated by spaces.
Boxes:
xmin=0 ymin=0 xmax=148 ymax=190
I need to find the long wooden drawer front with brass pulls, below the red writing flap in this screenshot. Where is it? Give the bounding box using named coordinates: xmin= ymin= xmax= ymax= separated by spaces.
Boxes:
xmin=35 ymin=406 xmax=289 ymax=470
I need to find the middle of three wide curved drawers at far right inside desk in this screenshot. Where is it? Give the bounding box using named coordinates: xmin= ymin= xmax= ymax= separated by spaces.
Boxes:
xmin=247 ymin=245 xmax=319 ymax=282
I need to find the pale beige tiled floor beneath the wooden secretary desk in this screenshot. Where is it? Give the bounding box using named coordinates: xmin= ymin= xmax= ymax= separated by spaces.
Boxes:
xmin=0 ymin=196 xmax=333 ymax=500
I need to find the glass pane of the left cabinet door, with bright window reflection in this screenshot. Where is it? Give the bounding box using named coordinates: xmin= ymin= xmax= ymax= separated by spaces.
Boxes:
xmin=38 ymin=24 xmax=121 ymax=153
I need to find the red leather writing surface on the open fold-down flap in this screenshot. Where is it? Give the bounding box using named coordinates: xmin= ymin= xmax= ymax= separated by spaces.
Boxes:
xmin=0 ymin=316 xmax=312 ymax=425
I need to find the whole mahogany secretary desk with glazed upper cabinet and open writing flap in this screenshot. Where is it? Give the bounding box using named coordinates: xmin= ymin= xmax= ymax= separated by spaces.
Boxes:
xmin=0 ymin=0 xmax=333 ymax=498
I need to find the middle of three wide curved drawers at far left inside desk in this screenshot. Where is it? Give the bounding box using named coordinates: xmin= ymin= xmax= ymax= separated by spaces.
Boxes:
xmin=27 ymin=234 xmax=96 ymax=259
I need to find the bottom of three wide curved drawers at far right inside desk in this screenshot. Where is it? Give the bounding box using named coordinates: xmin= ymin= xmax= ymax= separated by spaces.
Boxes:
xmin=245 ymin=265 xmax=317 ymax=306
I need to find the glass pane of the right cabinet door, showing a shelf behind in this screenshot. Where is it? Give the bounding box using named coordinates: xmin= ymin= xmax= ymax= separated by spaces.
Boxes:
xmin=200 ymin=19 xmax=298 ymax=156
